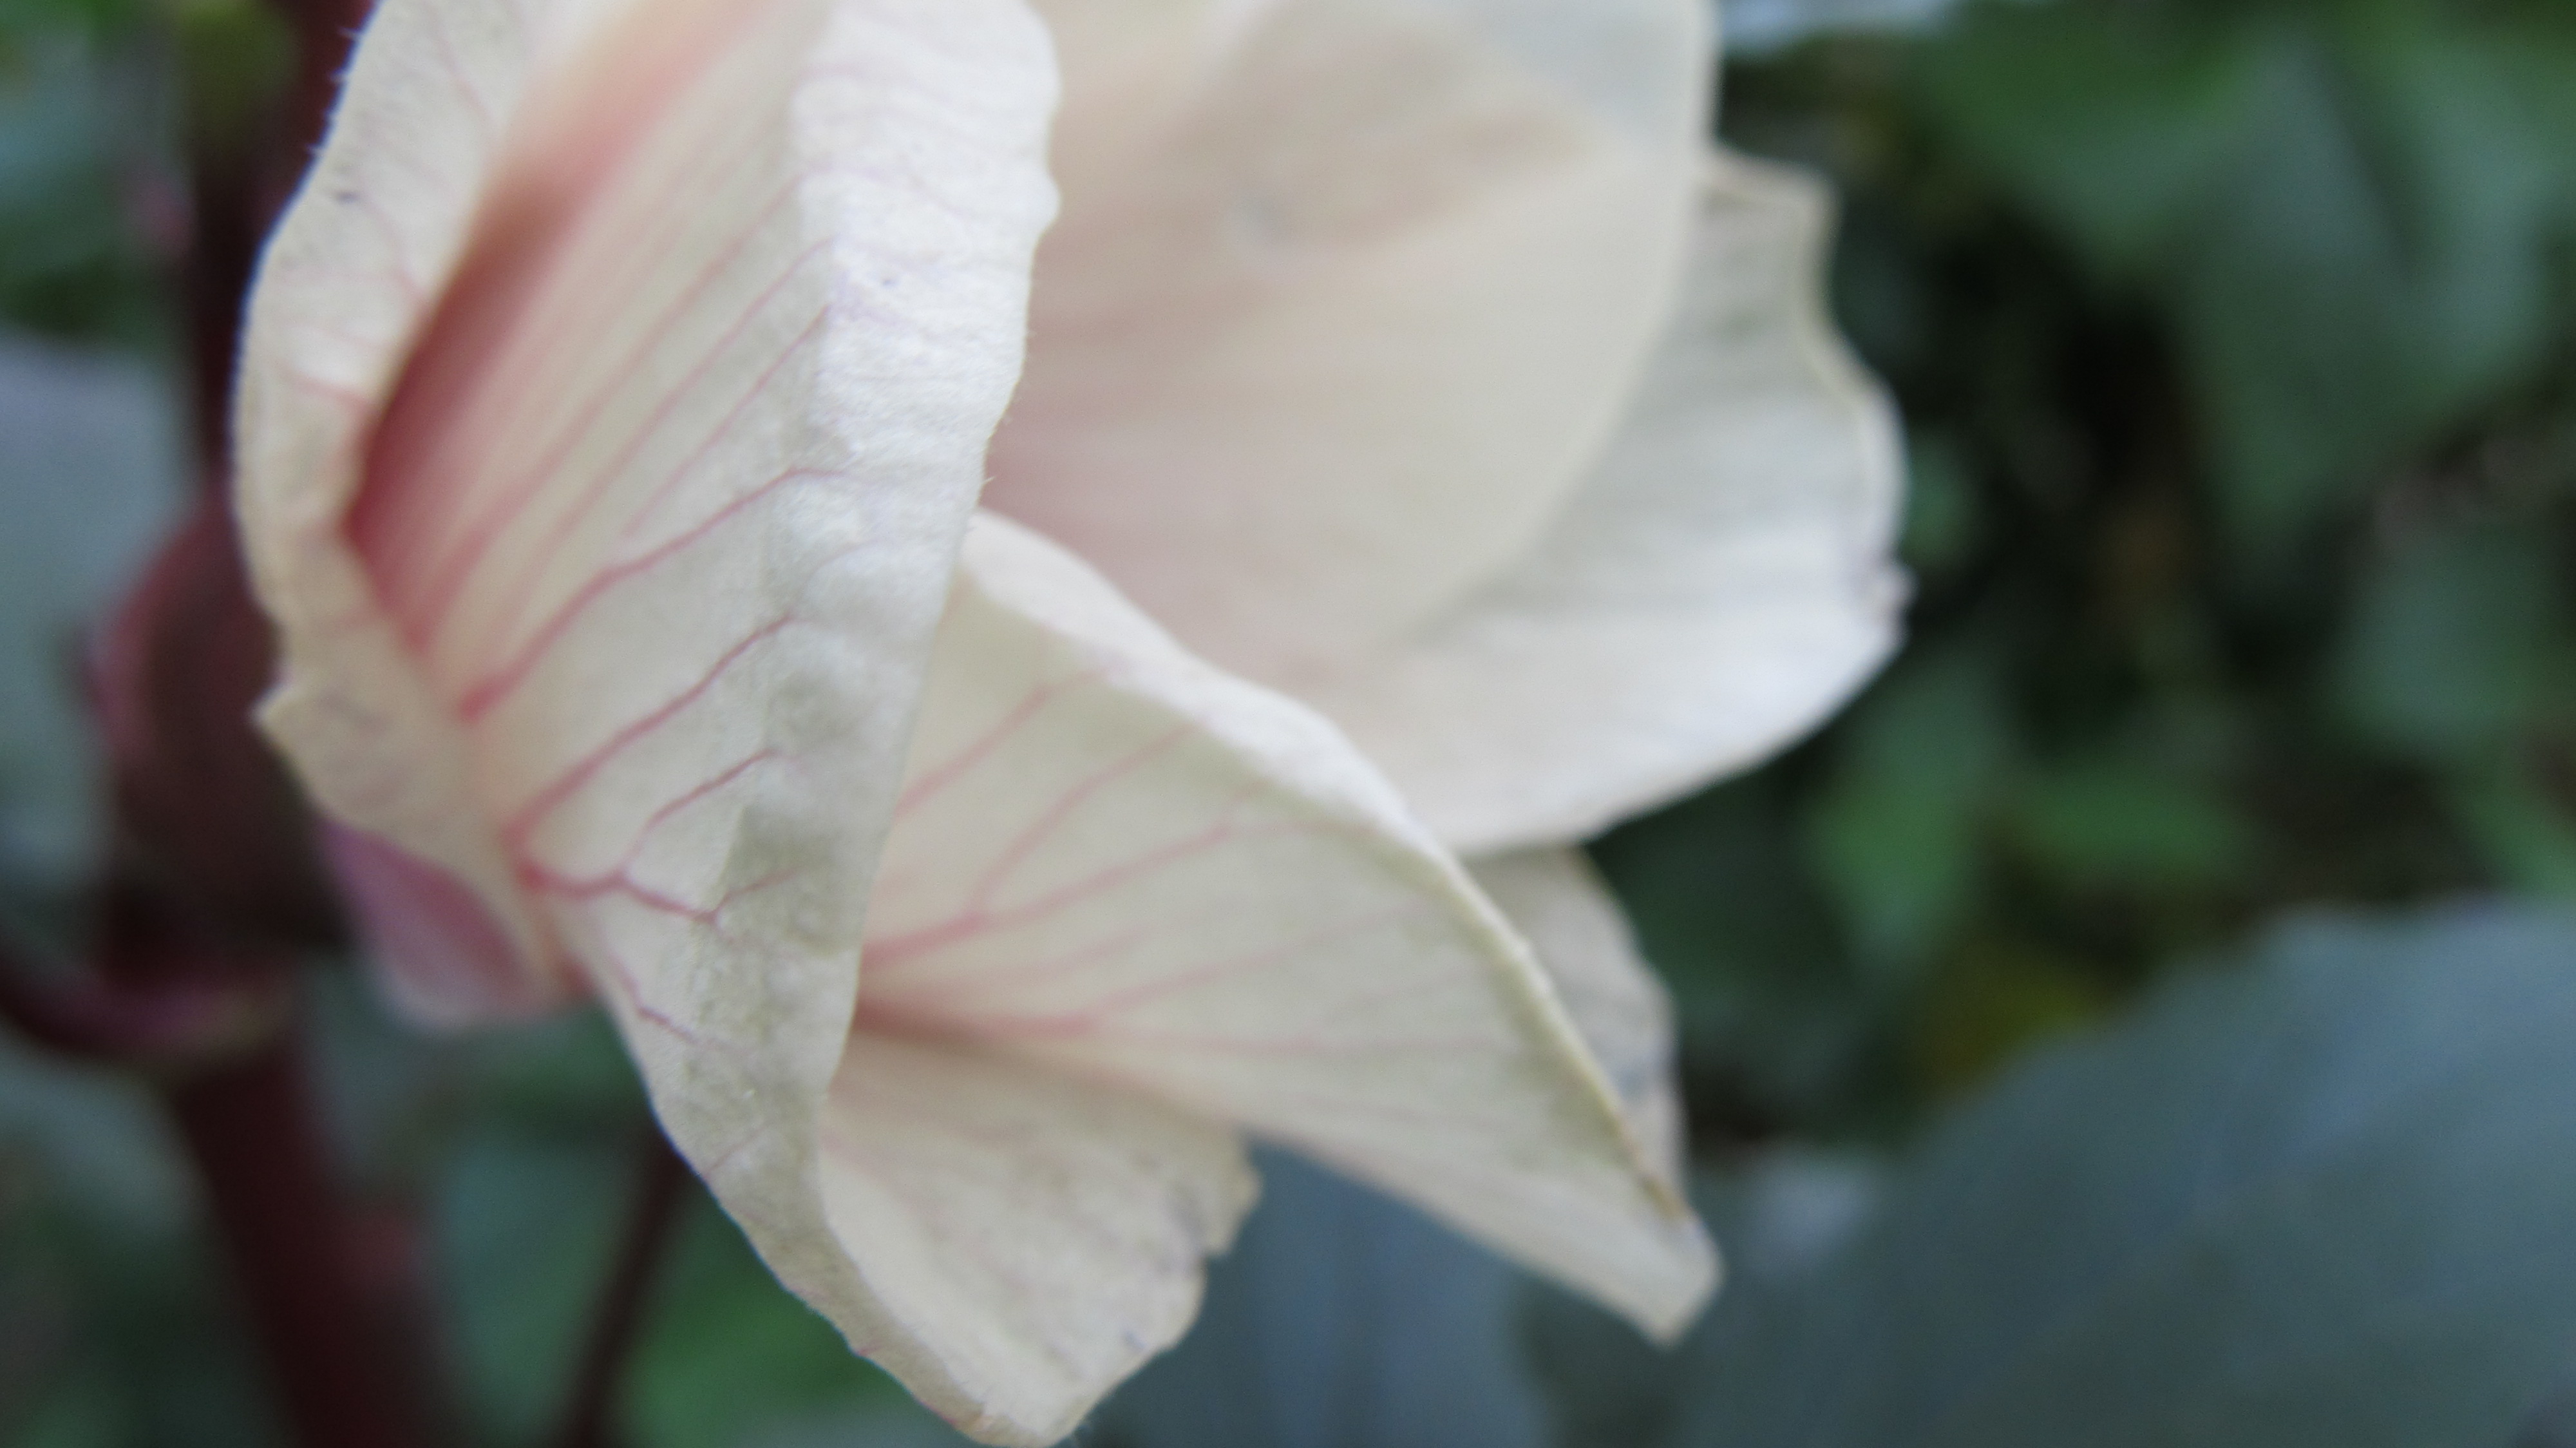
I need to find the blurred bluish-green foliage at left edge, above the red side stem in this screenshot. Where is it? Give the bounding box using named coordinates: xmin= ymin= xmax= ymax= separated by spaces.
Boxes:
xmin=0 ymin=0 xmax=185 ymax=925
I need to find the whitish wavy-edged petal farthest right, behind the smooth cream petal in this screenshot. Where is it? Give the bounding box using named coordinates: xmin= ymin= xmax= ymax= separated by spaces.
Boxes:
xmin=1298 ymin=147 xmax=1904 ymax=850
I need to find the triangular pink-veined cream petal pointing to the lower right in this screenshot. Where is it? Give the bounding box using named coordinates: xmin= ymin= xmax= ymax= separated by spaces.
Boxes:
xmin=853 ymin=515 xmax=1713 ymax=1332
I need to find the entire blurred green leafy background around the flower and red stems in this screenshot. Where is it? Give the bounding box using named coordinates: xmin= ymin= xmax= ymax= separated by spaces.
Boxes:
xmin=0 ymin=0 xmax=2576 ymax=1448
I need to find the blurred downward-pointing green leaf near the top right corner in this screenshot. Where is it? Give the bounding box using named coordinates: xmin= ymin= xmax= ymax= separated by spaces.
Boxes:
xmin=2166 ymin=28 xmax=2550 ymax=544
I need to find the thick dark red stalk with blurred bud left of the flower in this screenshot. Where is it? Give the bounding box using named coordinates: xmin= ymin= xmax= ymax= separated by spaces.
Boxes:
xmin=64 ymin=0 xmax=430 ymax=1448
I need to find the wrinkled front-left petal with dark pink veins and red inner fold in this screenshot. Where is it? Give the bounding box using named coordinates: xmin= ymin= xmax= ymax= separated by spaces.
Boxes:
xmin=240 ymin=0 xmax=1054 ymax=1391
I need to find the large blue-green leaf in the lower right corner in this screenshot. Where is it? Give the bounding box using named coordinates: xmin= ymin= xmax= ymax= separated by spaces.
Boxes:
xmin=1628 ymin=907 xmax=2576 ymax=1448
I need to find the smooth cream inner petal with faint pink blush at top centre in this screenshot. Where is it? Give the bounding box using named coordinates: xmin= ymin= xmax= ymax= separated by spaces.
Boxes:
xmin=987 ymin=0 xmax=1708 ymax=685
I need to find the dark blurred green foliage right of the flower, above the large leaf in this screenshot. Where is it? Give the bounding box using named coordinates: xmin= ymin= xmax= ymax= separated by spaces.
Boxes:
xmin=1597 ymin=0 xmax=2576 ymax=1147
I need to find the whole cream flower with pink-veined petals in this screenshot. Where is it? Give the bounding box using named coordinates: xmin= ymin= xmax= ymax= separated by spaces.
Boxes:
xmin=237 ymin=0 xmax=1893 ymax=1443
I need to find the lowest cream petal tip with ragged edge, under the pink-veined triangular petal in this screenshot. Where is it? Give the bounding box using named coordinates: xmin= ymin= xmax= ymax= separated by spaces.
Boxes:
xmin=822 ymin=1031 xmax=1255 ymax=1445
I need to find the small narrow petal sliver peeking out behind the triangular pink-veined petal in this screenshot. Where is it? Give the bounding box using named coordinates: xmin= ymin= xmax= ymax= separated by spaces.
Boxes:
xmin=1468 ymin=848 xmax=1685 ymax=1190
